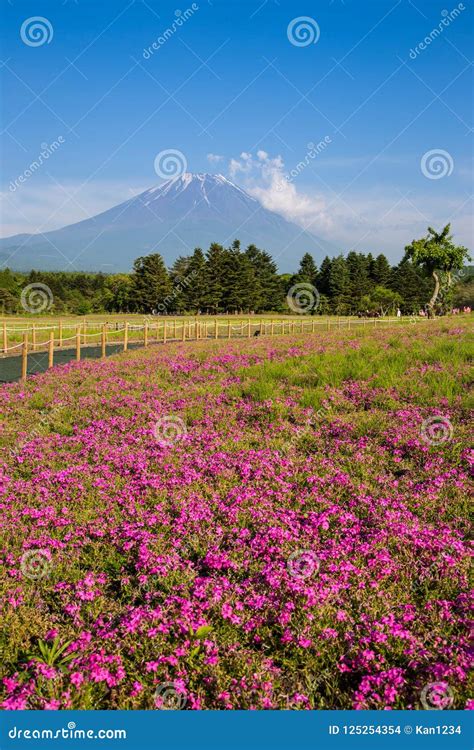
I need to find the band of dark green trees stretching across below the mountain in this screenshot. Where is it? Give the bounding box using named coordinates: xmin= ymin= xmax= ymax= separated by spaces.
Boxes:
xmin=0 ymin=226 xmax=474 ymax=315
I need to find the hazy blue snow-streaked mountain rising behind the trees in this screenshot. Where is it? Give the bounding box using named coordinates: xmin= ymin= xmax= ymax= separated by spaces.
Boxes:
xmin=0 ymin=172 xmax=336 ymax=273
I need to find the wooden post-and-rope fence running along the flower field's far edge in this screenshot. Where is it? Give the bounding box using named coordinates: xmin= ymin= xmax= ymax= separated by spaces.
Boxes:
xmin=1 ymin=317 xmax=426 ymax=380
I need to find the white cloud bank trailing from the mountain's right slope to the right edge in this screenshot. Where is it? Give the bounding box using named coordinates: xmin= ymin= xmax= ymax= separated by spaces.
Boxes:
xmin=229 ymin=150 xmax=472 ymax=259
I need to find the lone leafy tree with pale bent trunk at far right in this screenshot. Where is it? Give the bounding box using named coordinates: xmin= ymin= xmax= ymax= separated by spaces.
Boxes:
xmin=405 ymin=224 xmax=470 ymax=318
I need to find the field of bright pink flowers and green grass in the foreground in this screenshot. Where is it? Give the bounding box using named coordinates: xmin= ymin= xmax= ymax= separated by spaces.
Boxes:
xmin=0 ymin=319 xmax=471 ymax=710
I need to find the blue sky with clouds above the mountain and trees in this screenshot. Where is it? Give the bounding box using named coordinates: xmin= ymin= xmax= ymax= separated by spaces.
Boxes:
xmin=0 ymin=0 xmax=473 ymax=260
